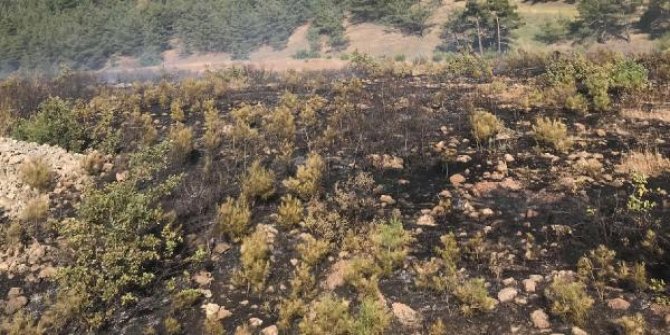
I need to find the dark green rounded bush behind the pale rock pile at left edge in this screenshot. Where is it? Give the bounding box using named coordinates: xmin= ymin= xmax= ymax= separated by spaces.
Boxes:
xmin=12 ymin=98 xmax=86 ymax=151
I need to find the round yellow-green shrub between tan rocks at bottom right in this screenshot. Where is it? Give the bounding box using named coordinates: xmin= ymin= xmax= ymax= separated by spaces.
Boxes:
xmin=544 ymin=277 xmax=593 ymax=324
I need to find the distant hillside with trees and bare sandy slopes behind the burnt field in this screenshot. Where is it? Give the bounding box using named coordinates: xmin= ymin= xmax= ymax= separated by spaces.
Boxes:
xmin=0 ymin=0 xmax=670 ymax=76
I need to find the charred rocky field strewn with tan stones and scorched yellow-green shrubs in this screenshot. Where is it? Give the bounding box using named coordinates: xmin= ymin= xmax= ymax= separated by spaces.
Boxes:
xmin=0 ymin=59 xmax=670 ymax=335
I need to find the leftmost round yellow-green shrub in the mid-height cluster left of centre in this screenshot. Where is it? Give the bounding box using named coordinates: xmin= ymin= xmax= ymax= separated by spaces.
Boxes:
xmin=216 ymin=197 xmax=251 ymax=240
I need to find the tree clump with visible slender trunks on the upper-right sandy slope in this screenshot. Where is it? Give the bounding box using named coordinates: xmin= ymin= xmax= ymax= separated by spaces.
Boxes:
xmin=440 ymin=0 xmax=523 ymax=55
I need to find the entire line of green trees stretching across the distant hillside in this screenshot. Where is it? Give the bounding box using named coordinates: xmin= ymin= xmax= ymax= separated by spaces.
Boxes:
xmin=0 ymin=0 xmax=670 ymax=75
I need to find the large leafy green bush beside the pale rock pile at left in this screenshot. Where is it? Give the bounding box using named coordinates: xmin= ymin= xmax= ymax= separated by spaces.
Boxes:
xmin=57 ymin=145 xmax=181 ymax=324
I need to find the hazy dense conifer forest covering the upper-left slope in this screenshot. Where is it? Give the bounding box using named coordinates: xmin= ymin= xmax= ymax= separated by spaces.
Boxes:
xmin=0 ymin=0 xmax=436 ymax=73
